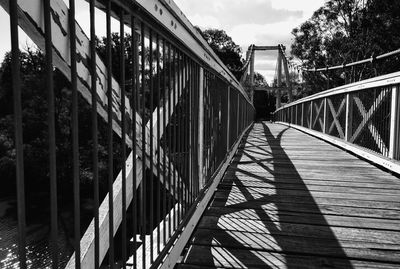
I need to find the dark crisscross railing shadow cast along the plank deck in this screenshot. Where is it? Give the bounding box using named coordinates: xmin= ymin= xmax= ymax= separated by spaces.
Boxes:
xmin=188 ymin=123 xmax=353 ymax=268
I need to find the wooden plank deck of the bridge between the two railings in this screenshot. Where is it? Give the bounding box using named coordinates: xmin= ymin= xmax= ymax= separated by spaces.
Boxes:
xmin=178 ymin=123 xmax=400 ymax=268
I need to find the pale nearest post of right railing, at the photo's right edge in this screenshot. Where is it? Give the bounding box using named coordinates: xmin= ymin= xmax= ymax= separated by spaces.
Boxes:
xmin=389 ymin=86 xmax=399 ymax=159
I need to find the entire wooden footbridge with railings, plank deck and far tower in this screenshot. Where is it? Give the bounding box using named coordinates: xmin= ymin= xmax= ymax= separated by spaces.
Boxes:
xmin=0 ymin=0 xmax=400 ymax=269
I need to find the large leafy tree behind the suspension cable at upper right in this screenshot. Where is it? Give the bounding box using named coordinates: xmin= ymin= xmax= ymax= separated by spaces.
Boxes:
xmin=291 ymin=0 xmax=400 ymax=93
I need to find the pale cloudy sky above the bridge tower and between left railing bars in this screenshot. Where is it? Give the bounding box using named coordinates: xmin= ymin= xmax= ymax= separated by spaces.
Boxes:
xmin=0 ymin=0 xmax=324 ymax=82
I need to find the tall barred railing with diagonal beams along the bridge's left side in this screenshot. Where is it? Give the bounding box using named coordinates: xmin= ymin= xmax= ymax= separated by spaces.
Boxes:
xmin=0 ymin=0 xmax=254 ymax=268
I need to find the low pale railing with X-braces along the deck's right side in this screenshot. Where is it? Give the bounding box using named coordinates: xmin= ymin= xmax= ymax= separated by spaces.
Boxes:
xmin=274 ymin=72 xmax=400 ymax=173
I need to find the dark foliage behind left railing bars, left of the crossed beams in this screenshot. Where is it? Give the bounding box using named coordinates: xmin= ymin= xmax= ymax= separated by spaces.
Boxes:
xmin=0 ymin=48 xmax=121 ymax=205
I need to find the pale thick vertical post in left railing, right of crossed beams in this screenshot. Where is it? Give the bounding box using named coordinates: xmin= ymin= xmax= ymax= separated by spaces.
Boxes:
xmin=198 ymin=67 xmax=205 ymax=190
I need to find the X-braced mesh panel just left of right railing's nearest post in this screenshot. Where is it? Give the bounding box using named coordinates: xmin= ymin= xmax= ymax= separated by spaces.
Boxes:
xmin=348 ymin=87 xmax=391 ymax=156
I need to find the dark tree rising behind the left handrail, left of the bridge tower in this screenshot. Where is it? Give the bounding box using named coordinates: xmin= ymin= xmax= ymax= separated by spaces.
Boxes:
xmin=195 ymin=27 xmax=244 ymax=79
